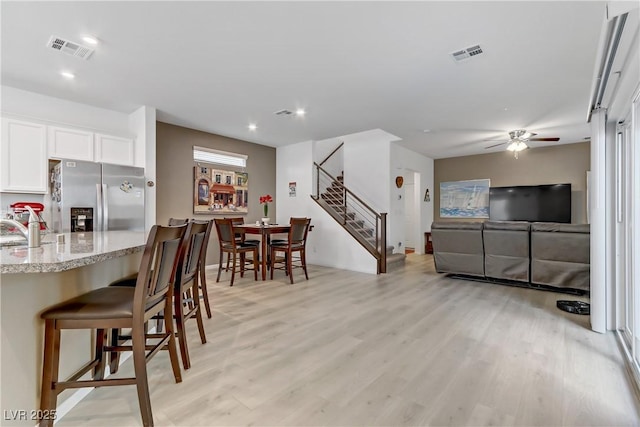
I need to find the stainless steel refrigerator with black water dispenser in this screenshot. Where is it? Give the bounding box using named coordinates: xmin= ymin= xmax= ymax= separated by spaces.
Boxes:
xmin=51 ymin=160 xmax=145 ymax=233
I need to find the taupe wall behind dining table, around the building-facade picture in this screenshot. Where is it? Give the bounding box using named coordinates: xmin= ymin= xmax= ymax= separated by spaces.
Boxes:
xmin=156 ymin=122 xmax=277 ymax=264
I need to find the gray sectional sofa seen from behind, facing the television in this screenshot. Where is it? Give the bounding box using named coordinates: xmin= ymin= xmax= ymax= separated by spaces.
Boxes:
xmin=431 ymin=221 xmax=590 ymax=293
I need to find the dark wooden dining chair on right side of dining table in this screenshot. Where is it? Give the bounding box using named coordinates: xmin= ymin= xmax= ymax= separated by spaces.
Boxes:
xmin=269 ymin=218 xmax=311 ymax=284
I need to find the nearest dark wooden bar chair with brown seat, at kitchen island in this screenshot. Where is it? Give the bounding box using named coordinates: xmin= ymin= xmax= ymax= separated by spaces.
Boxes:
xmin=39 ymin=225 xmax=187 ymax=426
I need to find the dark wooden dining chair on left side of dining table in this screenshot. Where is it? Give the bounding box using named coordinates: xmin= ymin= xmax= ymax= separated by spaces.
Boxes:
xmin=215 ymin=218 xmax=259 ymax=286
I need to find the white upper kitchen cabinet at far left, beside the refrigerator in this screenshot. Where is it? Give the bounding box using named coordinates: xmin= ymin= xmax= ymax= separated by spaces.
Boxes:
xmin=0 ymin=117 xmax=49 ymax=194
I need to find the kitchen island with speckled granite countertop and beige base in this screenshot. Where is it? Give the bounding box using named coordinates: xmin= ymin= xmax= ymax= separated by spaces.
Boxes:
xmin=0 ymin=231 xmax=146 ymax=426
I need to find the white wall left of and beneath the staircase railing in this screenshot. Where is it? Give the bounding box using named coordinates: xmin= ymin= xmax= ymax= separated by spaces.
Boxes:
xmin=275 ymin=141 xmax=377 ymax=274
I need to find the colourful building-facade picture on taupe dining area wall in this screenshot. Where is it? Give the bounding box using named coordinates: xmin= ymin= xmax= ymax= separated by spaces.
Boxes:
xmin=193 ymin=166 xmax=249 ymax=215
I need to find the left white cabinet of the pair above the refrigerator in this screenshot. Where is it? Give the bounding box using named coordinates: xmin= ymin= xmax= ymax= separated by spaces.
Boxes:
xmin=48 ymin=126 xmax=94 ymax=161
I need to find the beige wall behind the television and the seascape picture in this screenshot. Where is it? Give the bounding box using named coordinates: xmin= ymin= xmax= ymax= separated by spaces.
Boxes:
xmin=433 ymin=142 xmax=590 ymax=223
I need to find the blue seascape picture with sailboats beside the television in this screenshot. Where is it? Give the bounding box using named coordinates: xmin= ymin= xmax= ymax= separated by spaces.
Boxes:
xmin=440 ymin=179 xmax=491 ymax=218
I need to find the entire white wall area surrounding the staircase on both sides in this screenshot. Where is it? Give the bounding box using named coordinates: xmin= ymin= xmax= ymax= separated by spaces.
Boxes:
xmin=276 ymin=129 xmax=433 ymax=274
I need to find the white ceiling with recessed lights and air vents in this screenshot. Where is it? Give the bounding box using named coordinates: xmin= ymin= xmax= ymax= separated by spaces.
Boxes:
xmin=1 ymin=1 xmax=605 ymax=158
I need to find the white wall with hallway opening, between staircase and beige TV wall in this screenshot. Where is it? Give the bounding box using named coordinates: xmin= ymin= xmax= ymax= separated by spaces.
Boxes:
xmin=389 ymin=144 xmax=433 ymax=254
